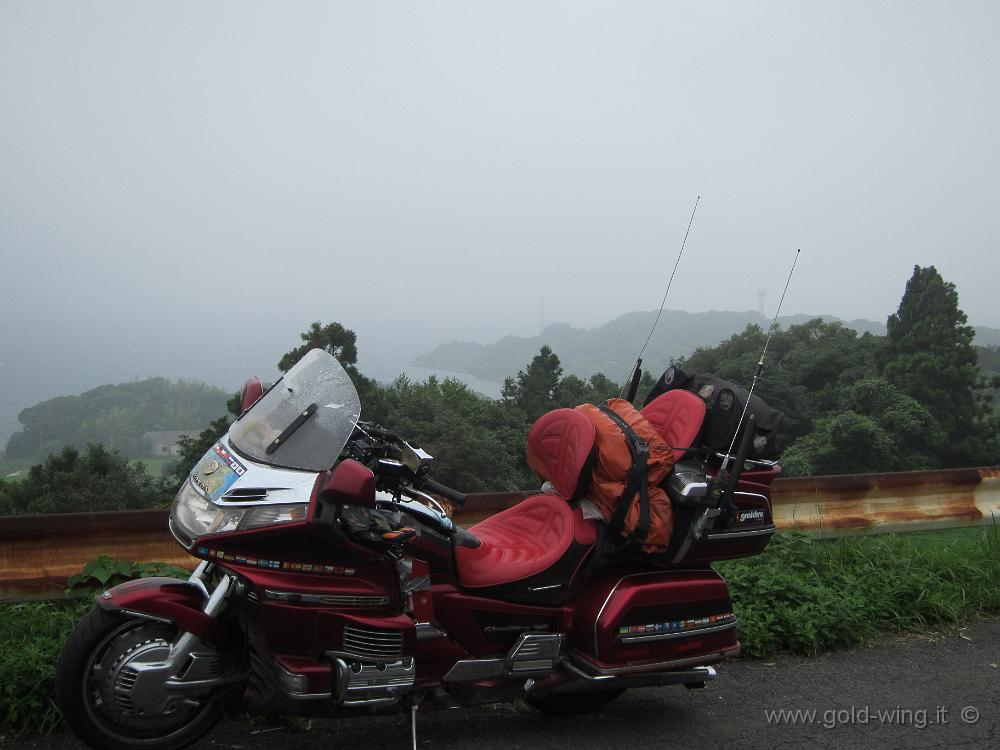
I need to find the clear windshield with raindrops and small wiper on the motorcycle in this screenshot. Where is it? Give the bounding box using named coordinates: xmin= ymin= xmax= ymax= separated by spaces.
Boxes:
xmin=229 ymin=349 xmax=361 ymax=471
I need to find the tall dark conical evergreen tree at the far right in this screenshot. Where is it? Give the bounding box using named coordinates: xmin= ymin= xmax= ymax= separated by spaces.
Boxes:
xmin=884 ymin=266 xmax=998 ymax=467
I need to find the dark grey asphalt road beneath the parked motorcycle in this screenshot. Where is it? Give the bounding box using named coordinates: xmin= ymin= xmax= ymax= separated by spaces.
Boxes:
xmin=5 ymin=620 xmax=1000 ymax=750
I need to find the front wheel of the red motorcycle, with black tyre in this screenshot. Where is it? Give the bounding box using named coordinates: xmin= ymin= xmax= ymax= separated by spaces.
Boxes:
xmin=56 ymin=607 xmax=221 ymax=750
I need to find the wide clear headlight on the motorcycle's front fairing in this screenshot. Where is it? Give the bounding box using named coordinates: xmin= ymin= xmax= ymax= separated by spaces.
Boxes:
xmin=170 ymin=480 xmax=309 ymax=539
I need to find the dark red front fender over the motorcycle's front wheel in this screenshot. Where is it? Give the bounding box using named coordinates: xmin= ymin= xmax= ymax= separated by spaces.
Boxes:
xmin=96 ymin=577 xmax=219 ymax=641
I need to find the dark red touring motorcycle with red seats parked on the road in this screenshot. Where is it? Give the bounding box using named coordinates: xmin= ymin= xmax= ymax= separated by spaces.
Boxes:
xmin=56 ymin=349 xmax=779 ymax=748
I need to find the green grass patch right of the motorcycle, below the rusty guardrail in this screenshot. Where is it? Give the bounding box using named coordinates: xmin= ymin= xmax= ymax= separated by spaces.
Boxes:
xmin=716 ymin=525 xmax=1000 ymax=657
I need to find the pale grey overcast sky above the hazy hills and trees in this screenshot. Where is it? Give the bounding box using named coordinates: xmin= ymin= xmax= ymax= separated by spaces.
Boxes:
xmin=0 ymin=0 xmax=1000 ymax=434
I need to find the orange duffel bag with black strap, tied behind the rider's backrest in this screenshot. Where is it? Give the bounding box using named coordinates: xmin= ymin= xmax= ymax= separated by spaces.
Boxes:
xmin=576 ymin=398 xmax=677 ymax=554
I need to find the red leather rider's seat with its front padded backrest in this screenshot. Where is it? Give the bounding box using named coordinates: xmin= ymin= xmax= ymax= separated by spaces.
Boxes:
xmin=455 ymin=409 xmax=597 ymax=588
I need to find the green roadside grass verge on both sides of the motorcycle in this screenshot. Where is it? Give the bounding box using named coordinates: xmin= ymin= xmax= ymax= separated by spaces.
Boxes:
xmin=0 ymin=525 xmax=1000 ymax=737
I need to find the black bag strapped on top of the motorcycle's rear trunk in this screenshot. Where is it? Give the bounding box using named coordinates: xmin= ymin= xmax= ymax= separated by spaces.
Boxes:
xmin=643 ymin=367 xmax=785 ymax=460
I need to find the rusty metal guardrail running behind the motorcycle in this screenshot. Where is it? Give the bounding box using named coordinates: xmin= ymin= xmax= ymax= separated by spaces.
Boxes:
xmin=0 ymin=467 xmax=1000 ymax=599
